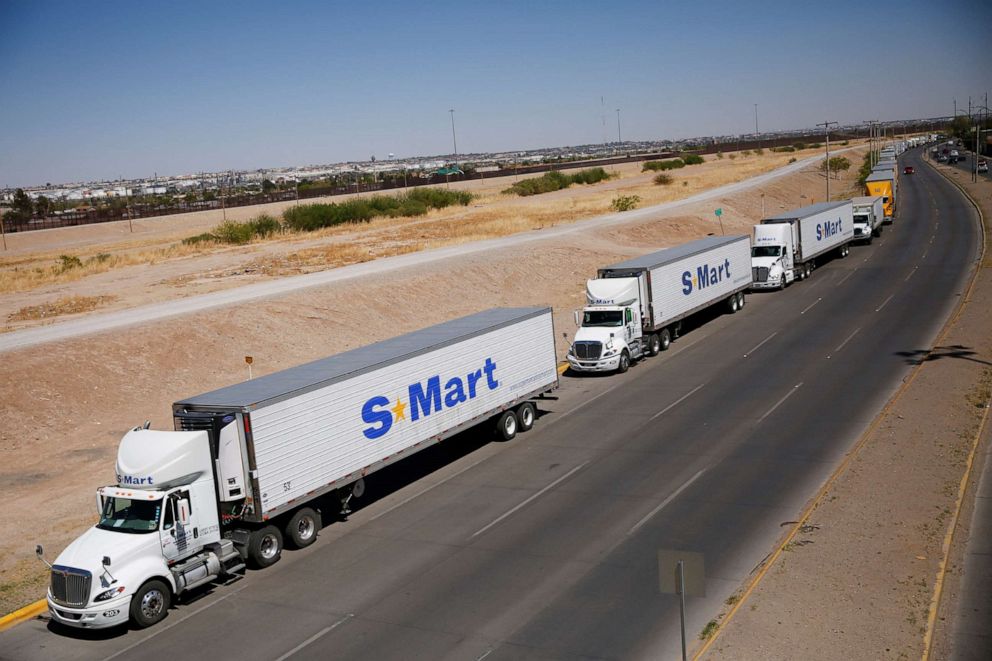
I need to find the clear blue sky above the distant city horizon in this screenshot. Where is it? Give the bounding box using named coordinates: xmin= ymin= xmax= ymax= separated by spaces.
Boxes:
xmin=0 ymin=0 xmax=992 ymax=188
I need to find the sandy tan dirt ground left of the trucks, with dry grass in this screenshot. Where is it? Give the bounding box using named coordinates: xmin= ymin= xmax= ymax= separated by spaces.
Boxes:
xmin=0 ymin=146 xmax=876 ymax=612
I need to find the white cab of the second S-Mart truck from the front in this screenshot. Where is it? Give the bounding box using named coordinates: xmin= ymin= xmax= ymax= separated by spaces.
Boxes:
xmin=567 ymin=278 xmax=643 ymax=372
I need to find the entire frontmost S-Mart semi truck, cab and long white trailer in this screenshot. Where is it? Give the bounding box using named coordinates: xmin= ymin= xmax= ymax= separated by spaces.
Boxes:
xmin=38 ymin=308 xmax=558 ymax=629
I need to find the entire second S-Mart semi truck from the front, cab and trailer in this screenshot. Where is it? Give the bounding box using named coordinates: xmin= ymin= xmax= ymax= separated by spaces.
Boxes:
xmin=567 ymin=236 xmax=751 ymax=372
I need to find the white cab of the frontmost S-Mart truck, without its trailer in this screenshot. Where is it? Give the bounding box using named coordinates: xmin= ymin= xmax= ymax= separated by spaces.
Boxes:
xmin=39 ymin=428 xmax=244 ymax=628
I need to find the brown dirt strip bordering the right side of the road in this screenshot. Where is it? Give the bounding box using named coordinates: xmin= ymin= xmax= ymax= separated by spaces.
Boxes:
xmin=697 ymin=165 xmax=992 ymax=660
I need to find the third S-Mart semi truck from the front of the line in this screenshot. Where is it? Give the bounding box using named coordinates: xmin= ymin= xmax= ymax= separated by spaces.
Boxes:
xmin=751 ymin=200 xmax=854 ymax=289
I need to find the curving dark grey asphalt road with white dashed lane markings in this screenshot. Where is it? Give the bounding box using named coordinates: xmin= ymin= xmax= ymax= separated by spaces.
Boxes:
xmin=0 ymin=150 xmax=979 ymax=661
